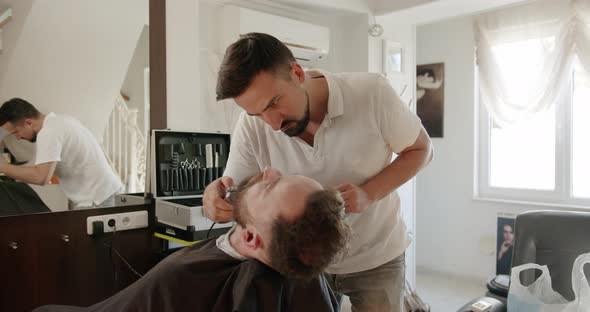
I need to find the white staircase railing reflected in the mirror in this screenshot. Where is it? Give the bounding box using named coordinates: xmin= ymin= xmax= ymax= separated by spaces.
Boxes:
xmin=101 ymin=95 xmax=147 ymax=193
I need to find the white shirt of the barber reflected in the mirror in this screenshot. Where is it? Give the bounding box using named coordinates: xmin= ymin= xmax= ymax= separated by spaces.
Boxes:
xmin=35 ymin=113 xmax=123 ymax=207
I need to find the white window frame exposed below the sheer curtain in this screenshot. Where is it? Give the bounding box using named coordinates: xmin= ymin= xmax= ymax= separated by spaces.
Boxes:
xmin=474 ymin=65 xmax=590 ymax=209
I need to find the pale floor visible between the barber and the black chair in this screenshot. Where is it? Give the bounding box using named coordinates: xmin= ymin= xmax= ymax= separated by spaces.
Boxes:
xmin=342 ymin=272 xmax=486 ymax=312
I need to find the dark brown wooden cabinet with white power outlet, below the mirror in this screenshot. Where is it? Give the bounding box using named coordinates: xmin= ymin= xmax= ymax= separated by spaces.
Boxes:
xmin=0 ymin=205 xmax=161 ymax=311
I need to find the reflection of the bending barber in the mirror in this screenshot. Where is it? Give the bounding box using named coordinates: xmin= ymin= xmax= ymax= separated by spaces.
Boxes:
xmin=0 ymin=98 xmax=122 ymax=208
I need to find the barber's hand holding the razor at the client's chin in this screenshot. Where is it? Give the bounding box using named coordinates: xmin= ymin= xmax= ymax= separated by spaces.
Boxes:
xmin=203 ymin=177 xmax=234 ymax=223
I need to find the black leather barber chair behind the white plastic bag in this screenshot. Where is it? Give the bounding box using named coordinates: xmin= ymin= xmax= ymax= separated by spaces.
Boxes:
xmin=457 ymin=211 xmax=590 ymax=312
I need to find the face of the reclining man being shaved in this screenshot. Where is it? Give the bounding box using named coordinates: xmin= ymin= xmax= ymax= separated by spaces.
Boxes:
xmin=231 ymin=168 xmax=323 ymax=240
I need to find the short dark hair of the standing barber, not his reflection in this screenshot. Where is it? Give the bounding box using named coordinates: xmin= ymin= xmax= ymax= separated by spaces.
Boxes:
xmin=216 ymin=33 xmax=295 ymax=101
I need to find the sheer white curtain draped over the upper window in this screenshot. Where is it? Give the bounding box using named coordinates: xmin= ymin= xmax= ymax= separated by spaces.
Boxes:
xmin=474 ymin=0 xmax=590 ymax=126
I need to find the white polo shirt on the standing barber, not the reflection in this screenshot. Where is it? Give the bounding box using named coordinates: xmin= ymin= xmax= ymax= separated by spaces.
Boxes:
xmin=225 ymin=71 xmax=421 ymax=274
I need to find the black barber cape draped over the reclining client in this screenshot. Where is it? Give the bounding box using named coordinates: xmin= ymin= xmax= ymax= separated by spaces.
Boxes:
xmin=36 ymin=239 xmax=340 ymax=312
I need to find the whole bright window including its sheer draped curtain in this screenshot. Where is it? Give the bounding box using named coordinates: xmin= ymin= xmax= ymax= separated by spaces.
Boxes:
xmin=474 ymin=0 xmax=590 ymax=208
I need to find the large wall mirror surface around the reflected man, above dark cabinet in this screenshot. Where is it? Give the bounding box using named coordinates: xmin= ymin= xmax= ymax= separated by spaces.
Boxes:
xmin=0 ymin=0 xmax=150 ymax=216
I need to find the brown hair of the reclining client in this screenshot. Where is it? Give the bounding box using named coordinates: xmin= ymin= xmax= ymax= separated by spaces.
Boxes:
xmin=270 ymin=190 xmax=351 ymax=280
